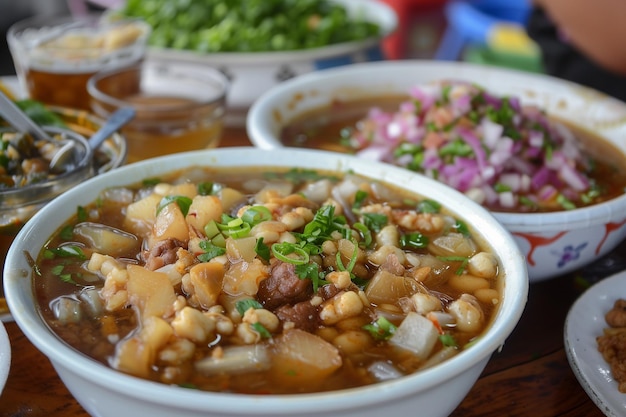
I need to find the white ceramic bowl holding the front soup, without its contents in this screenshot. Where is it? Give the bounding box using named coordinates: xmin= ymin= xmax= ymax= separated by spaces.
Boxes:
xmin=4 ymin=147 xmax=528 ymax=417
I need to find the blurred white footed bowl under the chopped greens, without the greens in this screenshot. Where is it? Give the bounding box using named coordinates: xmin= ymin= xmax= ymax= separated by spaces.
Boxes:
xmin=147 ymin=0 xmax=398 ymax=125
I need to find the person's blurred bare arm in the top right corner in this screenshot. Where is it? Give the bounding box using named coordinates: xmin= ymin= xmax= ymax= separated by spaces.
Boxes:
xmin=534 ymin=0 xmax=626 ymax=75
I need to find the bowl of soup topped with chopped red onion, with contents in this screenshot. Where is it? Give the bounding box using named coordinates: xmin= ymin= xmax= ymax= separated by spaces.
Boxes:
xmin=247 ymin=61 xmax=626 ymax=281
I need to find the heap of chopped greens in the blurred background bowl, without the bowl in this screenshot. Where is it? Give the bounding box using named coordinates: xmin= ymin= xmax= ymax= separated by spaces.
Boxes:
xmin=119 ymin=0 xmax=380 ymax=52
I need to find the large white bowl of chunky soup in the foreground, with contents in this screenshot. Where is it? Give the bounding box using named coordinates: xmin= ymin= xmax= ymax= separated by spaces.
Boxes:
xmin=4 ymin=147 xmax=528 ymax=417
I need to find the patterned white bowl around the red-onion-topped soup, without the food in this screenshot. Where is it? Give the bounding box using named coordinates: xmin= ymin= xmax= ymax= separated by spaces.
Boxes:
xmin=247 ymin=61 xmax=626 ymax=282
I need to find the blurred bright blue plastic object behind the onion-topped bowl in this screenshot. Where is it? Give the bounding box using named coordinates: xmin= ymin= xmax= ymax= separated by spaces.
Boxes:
xmin=435 ymin=0 xmax=531 ymax=61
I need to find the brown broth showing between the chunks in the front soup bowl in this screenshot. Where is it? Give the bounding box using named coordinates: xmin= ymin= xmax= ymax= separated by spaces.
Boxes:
xmin=35 ymin=165 xmax=502 ymax=394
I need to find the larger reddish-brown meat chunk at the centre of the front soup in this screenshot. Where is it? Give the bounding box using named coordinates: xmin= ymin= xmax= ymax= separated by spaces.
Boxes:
xmin=257 ymin=262 xmax=313 ymax=310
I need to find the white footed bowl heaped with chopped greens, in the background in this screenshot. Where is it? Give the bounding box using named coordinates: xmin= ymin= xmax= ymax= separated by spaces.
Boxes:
xmin=111 ymin=0 xmax=397 ymax=123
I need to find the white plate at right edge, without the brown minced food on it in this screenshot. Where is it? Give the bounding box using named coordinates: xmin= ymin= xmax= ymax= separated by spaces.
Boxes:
xmin=564 ymin=271 xmax=626 ymax=417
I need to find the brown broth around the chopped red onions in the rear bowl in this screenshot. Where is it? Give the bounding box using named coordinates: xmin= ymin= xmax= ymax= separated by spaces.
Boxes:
xmin=280 ymin=97 xmax=626 ymax=212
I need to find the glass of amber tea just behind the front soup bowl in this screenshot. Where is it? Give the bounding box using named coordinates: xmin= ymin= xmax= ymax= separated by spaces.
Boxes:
xmin=87 ymin=60 xmax=229 ymax=162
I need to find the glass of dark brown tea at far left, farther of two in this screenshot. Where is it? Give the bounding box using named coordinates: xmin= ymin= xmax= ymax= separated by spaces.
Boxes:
xmin=7 ymin=15 xmax=151 ymax=110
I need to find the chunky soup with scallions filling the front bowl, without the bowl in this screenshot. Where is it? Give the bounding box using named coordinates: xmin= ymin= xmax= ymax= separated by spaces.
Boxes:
xmin=34 ymin=164 xmax=503 ymax=394
